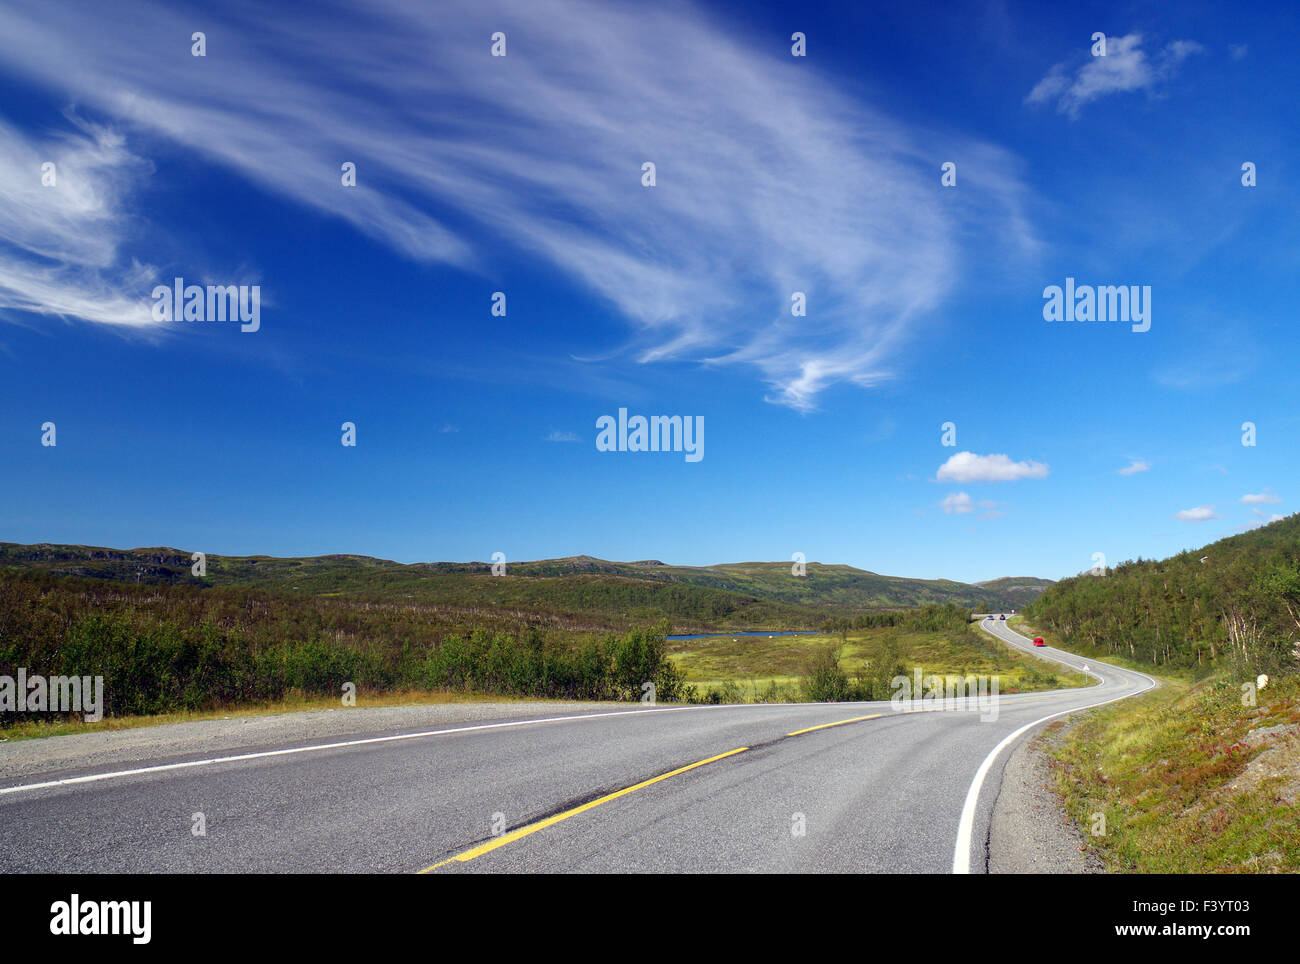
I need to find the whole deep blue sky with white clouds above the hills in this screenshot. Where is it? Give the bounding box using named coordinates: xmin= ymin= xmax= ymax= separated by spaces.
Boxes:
xmin=0 ymin=0 xmax=1300 ymax=581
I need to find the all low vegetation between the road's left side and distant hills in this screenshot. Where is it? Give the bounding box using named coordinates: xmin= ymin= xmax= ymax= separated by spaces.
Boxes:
xmin=0 ymin=569 xmax=1082 ymax=726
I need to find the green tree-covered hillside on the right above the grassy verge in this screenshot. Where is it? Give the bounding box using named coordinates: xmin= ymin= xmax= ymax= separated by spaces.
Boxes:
xmin=1026 ymin=514 xmax=1300 ymax=678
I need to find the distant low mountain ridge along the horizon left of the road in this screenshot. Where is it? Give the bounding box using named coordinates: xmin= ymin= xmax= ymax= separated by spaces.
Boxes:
xmin=0 ymin=543 xmax=1052 ymax=615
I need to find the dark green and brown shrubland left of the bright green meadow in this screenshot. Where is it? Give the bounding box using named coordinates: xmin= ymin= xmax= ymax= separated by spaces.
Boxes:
xmin=0 ymin=570 xmax=690 ymax=724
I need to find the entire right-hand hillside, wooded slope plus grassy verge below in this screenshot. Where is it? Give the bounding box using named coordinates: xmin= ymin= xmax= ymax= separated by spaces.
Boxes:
xmin=1028 ymin=516 xmax=1300 ymax=873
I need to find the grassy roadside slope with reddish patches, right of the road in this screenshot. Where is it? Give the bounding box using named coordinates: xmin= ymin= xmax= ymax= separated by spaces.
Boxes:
xmin=1013 ymin=618 xmax=1300 ymax=873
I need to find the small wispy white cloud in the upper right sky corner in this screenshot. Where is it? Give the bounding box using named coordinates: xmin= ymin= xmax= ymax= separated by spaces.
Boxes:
xmin=1024 ymin=34 xmax=1205 ymax=118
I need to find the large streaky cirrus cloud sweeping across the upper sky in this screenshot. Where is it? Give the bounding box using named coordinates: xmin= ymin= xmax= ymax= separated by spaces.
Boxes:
xmin=0 ymin=0 xmax=1036 ymax=411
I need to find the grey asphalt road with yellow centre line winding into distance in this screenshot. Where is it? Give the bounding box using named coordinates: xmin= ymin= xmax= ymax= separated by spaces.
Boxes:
xmin=0 ymin=620 xmax=1154 ymax=873
